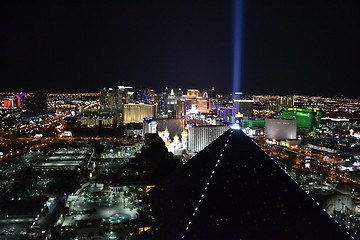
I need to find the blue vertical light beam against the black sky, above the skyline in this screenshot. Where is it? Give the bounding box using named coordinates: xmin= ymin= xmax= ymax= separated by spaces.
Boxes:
xmin=233 ymin=0 xmax=244 ymax=92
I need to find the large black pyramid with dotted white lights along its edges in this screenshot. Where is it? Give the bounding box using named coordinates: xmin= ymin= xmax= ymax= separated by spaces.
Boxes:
xmin=150 ymin=129 xmax=351 ymax=240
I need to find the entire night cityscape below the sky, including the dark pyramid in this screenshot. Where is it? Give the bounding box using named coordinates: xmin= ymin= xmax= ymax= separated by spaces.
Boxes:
xmin=0 ymin=86 xmax=360 ymax=237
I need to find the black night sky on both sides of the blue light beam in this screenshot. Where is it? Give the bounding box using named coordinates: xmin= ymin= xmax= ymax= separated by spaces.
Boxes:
xmin=0 ymin=0 xmax=360 ymax=97
